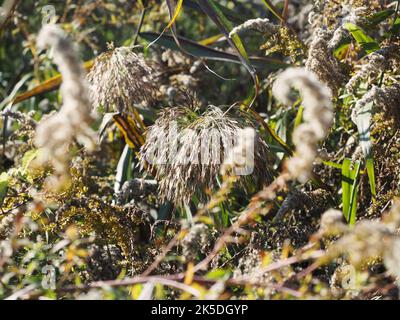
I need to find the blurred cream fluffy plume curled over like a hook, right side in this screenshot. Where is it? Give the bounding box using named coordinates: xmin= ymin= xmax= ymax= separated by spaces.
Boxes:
xmin=272 ymin=68 xmax=333 ymax=183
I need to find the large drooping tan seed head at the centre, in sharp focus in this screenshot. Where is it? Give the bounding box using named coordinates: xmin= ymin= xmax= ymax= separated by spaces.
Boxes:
xmin=141 ymin=98 xmax=271 ymax=204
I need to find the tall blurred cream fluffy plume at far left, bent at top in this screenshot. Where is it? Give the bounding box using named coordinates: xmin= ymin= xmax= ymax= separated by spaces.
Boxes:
xmin=35 ymin=25 xmax=96 ymax=185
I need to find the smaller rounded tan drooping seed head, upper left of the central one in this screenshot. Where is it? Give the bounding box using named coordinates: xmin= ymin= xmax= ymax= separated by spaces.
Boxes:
xmin=87 ymin=47 xmax=156 ymax=115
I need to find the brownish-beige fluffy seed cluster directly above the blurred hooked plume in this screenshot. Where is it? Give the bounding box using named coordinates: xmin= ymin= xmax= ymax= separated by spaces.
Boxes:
xmin=305 ymin=29 xmax=345 ymax=95
